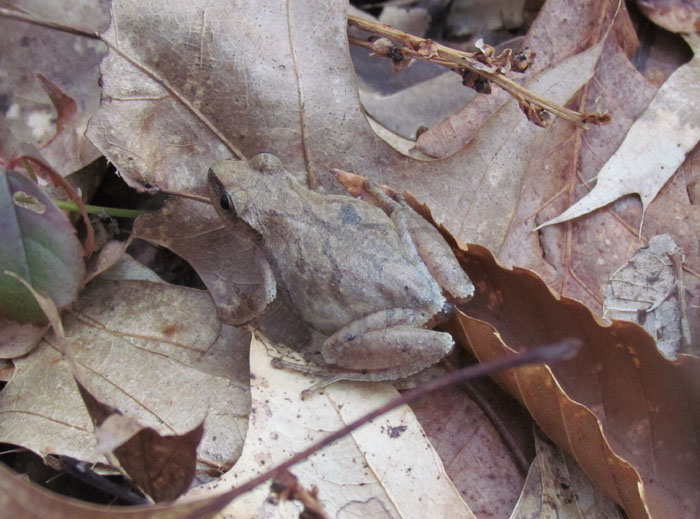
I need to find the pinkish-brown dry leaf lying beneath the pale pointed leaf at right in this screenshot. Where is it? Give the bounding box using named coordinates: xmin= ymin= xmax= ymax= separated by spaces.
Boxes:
xmin=493 ymin=33 xmax=700 ymax=312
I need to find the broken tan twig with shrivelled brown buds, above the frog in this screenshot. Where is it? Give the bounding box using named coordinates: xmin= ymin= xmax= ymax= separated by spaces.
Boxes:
xmin=348 ymin=15 xmax=610 ymax=126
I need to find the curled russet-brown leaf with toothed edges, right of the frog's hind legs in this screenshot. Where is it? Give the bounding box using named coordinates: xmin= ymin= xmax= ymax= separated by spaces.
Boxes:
xmin=459 ymin=246 xmax=700 ymax=519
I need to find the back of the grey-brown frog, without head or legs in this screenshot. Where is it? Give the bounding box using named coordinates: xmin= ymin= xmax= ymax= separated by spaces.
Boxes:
xmin=266 ymin=195 xmax=444 ymax=334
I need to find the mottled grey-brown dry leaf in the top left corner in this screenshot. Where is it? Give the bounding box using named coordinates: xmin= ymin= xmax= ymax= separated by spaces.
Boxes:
xmin=0 ymin=0 xmax=108 ymax=175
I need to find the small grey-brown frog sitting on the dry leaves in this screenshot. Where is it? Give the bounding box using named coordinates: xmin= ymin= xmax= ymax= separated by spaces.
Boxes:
xmin=208 ymin=154 xmax=474 ymax=386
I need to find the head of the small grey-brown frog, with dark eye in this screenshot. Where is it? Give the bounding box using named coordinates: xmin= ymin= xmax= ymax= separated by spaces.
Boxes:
xmin=207 ymin=153 xmax=285 ymax=223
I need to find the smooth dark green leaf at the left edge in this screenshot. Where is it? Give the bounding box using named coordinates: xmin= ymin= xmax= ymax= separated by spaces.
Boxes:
xmin=0 ymin=171 xmax=85 ymax=324
